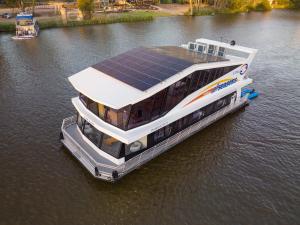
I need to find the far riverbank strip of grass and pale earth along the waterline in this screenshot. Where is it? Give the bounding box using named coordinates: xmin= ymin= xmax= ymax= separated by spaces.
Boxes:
xmin=0 ymin=4 xmax=298 ymax=32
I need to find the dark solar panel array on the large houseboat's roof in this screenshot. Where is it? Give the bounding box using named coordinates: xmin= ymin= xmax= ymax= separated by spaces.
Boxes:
xmin=92 ymin=46 xmax=227 ymax=91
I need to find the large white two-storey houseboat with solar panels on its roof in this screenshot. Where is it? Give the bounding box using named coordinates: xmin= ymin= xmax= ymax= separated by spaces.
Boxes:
xmin=60 ymin=39 xmax=257 ymax=181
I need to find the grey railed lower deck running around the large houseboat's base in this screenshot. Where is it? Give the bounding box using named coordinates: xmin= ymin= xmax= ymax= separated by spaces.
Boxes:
xmin=62 ymin=98 xmax=248 ymax=181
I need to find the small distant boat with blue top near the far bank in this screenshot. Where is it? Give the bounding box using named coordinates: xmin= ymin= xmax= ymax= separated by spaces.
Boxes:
xmin=13 ymin=13 xmax=39 ymax=40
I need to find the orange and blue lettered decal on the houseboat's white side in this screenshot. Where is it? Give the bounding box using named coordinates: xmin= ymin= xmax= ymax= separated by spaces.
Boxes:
xmin=184 ymin=78 xmax=237 ymax=107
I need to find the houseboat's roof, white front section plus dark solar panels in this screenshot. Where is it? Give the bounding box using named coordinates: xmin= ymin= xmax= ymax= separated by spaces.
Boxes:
xmin=69 ymin=46 xmax=228 ymax=109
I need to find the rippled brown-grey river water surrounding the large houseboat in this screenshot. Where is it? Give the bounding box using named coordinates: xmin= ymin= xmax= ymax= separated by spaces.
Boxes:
xmin=0 ymin=11 xmax=300 ymax=225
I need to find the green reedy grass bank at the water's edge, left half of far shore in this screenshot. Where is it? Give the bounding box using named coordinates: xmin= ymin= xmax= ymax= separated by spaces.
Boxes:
xmin=0 ymin=11 xmax=168 ymax=32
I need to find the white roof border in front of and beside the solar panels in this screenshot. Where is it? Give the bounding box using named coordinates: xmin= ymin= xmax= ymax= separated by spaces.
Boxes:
xmin=68 ymin=59 xmax=245 ymax=109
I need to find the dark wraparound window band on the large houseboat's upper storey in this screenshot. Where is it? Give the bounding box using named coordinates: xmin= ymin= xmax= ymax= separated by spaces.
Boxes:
xmin=80 ymin=65 xmax=240 ymax=130
